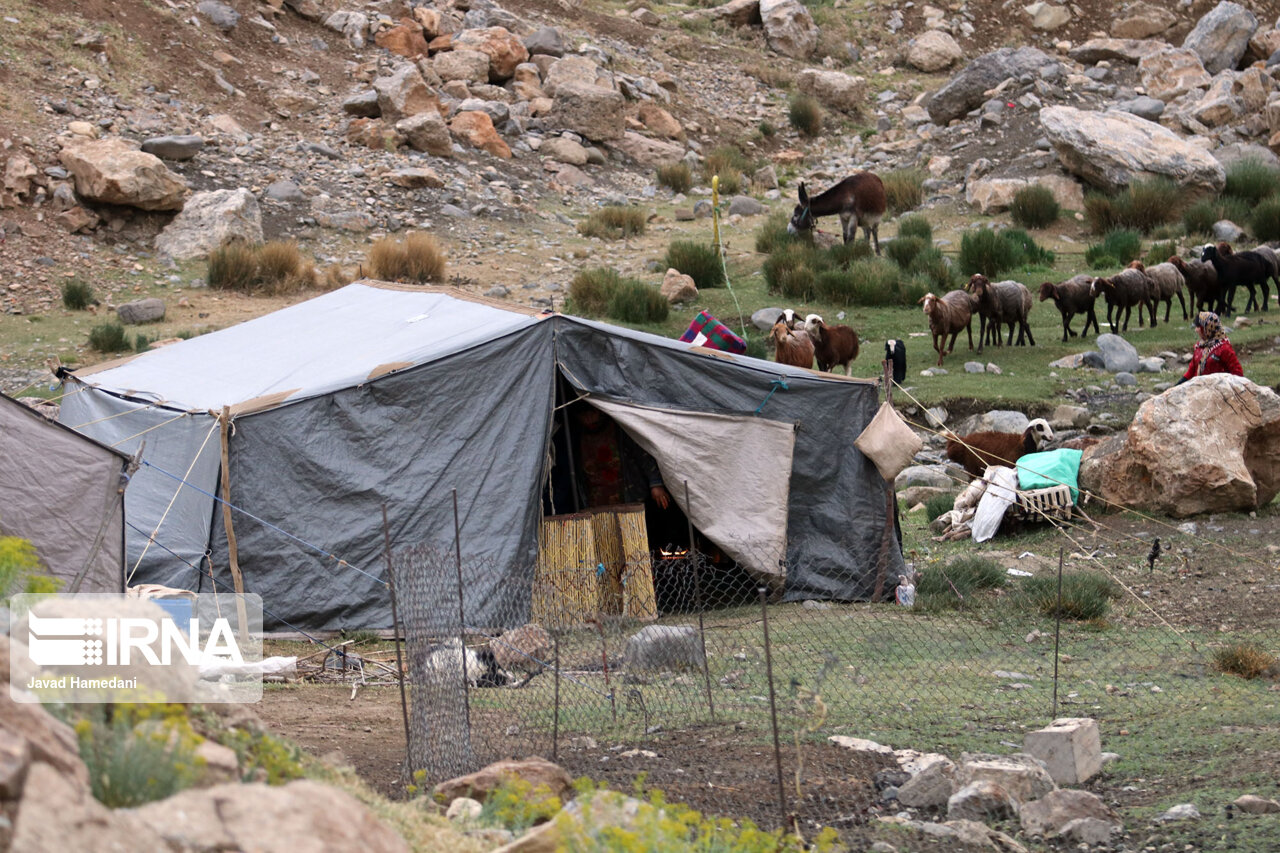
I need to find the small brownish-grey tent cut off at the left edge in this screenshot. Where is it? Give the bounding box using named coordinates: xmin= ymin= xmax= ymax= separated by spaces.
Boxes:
xmin=0 ymin=394 xmax=129 ymax=592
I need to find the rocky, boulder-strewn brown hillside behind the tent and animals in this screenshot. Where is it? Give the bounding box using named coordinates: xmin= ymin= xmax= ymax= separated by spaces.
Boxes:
xmin=0 ymin=0 xmax=1280 ymax=381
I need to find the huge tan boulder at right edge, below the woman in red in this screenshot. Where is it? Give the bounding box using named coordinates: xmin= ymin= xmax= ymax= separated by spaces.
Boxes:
xmin=1080 ymin=374 xmax=1280 ymax=517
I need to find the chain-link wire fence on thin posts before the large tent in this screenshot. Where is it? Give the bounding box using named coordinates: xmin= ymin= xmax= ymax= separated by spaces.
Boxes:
xmin=396 ymin=504 xmax=1280 ymax=838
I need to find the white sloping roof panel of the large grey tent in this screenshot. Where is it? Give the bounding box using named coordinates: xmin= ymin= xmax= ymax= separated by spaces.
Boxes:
xmin=76 ymin=282 xmax=538 ymax=411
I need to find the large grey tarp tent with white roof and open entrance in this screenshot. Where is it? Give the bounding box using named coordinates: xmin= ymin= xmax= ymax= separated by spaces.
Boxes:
xmin=63 ymin=282 xmax=902 ymax=630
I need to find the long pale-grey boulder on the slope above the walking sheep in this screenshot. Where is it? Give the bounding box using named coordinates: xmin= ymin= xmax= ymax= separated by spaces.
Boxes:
xmin=1041 ymin=106 xmax=1226 ymax=192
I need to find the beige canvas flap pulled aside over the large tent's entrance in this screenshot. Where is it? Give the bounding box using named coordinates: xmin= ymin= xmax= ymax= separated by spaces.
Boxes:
xmin=586 ymin=397 xmax=795 ymax=579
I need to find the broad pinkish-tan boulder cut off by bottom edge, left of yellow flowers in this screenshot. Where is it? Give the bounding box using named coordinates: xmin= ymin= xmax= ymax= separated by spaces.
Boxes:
xmin=131 ymin=779 xmax=410 ymax=853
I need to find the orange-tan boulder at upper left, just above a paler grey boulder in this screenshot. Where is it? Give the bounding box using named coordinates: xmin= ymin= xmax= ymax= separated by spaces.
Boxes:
xmin=58 ymin=136 xmax=187 ymax=210
